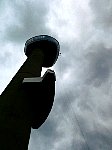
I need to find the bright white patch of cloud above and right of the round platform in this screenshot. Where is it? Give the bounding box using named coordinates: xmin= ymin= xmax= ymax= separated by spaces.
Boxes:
xmin=47 ymin=0 xmax=91 ymax=42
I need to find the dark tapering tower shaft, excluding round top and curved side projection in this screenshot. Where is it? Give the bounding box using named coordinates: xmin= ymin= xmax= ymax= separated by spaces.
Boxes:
xmin=0 ymin=48 xmax=44 ymax=150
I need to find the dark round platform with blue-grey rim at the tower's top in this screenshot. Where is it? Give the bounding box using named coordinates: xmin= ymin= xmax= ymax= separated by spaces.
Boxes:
xmin=24 ymin=35 xmax=60 ymax=67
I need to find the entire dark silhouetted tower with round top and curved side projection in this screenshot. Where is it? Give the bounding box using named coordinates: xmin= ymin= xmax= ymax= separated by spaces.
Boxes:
xmin=0 ymin=35 xmax=60 ymax=150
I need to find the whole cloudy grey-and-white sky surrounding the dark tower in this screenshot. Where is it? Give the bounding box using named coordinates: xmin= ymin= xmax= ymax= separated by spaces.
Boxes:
xmin=0 ymin=0 xmax=112 ymax=150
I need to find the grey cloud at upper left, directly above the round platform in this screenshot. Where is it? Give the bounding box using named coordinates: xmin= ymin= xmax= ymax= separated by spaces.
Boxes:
xmin=5 ymin=1 xmax=49 ymax=43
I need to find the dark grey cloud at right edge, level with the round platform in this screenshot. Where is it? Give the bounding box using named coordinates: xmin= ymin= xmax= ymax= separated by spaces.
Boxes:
xmin=86 ymin=43 xmax=112 ymax=86
